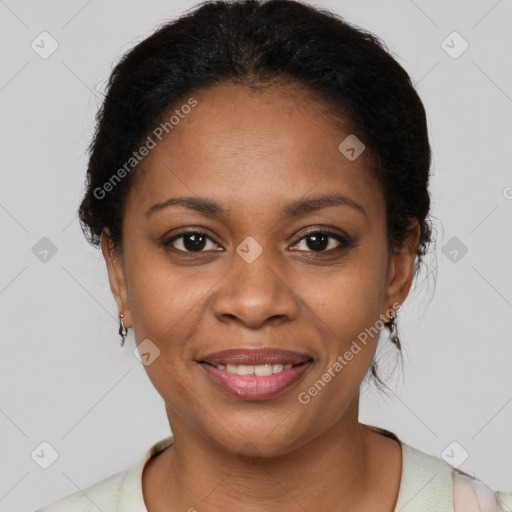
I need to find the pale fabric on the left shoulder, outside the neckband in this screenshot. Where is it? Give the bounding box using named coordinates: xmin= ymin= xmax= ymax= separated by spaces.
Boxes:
xmin=37 ymin=469 xmax=129 ymax=512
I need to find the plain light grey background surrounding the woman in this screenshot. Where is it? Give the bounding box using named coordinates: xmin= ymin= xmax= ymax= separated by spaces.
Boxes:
xmin=0 ymin=0 xmax=512 ymax=511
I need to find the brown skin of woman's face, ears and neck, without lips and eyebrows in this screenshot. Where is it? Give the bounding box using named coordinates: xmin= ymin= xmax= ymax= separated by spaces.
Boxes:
xmin=101 ymin=85 xmax=420 ymax=512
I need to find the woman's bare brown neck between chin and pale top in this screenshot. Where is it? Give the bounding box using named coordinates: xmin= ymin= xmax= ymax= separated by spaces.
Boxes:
xmin=143 ymin=401 xmax=397 ymax=512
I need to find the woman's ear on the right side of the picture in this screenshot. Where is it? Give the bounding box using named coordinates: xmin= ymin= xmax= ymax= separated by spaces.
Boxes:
xmin=384 ymin=219 xmax=421 ymax=311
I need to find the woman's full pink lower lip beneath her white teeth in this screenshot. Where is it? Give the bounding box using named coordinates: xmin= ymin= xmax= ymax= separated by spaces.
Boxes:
xmin=200 ymin=361 xmax=311 ymax=400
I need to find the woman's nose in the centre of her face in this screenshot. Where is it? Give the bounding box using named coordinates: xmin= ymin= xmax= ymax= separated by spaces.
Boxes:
xmin=213 ymin=246 xmax=298 ymax=329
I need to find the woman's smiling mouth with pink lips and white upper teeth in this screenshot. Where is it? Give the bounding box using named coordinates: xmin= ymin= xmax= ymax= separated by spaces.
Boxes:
xmin=197 ymin=348 xmax=313 ymax=400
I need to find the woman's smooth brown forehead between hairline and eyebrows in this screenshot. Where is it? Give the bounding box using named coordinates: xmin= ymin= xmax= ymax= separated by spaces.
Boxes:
xmin=130 ymin=81 xmax=383 ymax=220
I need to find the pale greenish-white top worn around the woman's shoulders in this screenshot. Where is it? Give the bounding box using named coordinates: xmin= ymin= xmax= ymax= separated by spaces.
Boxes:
xmin=36 ymin=429 xmax=512 ymax=512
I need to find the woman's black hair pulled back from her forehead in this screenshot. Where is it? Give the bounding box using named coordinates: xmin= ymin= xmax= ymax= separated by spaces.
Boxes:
xmin=79 ymin=0 xmax=432 ymax=389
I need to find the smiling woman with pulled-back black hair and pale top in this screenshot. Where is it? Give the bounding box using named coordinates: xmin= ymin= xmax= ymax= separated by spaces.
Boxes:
xmin=37 ymin=0 xmax=512 ymax=512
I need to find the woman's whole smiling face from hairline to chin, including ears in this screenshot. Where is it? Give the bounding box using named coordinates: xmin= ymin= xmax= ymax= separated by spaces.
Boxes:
xmin=102 ymin=85 xmax=419 ymax=455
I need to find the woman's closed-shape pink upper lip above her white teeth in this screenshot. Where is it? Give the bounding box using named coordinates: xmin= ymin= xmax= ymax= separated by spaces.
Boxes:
xmin=199 ymin=348 xmax=312 ymax=366
